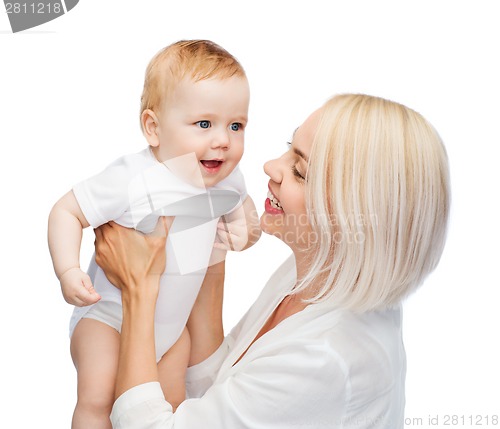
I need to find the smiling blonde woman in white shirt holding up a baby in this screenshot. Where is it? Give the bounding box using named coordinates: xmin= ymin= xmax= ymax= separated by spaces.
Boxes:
xmin=96 ymin=94 xmax=450 ymax=429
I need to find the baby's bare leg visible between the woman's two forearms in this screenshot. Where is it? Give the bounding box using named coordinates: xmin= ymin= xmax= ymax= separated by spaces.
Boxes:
xmin=158 ymin=328 xmax=191 ymax=411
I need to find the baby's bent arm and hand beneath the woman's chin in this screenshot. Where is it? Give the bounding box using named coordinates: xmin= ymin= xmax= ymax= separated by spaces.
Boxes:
xmin=214 ymin=196 xmax=262 ymax=251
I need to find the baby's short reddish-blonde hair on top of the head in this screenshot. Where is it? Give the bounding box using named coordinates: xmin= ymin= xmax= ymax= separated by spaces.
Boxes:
xmin=140 ymin=40 xmax=246 ymax=128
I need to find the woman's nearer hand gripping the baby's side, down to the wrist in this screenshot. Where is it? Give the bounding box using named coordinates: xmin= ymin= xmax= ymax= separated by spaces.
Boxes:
xmin=94 ymin=217 xmax=168 ymax=293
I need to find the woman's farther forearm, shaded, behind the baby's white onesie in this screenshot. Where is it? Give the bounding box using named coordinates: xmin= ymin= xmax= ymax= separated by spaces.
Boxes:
xmin=187 ymin=261 xmax=225 ymax=366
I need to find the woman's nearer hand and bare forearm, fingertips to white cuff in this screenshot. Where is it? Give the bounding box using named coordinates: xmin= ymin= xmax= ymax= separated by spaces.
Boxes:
xmin=95 ymin=218 xmax=168 ymax=397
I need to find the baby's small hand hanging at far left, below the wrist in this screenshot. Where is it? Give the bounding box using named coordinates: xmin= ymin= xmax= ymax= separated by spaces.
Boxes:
xmin=59 ymin=267 xmax=101 ymax=307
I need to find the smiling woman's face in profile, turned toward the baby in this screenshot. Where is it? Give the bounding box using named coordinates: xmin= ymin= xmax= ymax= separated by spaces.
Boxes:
xmin=260 ymin=110 xmax=320 ymax=251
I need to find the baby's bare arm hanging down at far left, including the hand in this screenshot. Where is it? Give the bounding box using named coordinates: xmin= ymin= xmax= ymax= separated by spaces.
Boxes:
xmin=48 ymin=191 xmax=101 ymax=307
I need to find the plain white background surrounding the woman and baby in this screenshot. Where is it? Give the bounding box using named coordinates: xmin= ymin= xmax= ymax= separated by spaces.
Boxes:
xmin=0 ymin=0 xmax=500 ymax=428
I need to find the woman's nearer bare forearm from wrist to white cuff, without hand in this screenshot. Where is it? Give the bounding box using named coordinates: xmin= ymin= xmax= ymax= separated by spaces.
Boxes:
xmin=115 ymin=277 xmax=159 ymax=398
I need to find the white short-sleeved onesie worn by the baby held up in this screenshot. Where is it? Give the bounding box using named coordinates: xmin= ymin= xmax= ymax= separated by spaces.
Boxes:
xmin=70 ymin=148 xmax=246 ymax=361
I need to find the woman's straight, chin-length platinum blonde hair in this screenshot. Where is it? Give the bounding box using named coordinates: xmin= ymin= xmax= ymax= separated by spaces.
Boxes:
xmin=296 ymin=94 xmax=450 ymax=312
